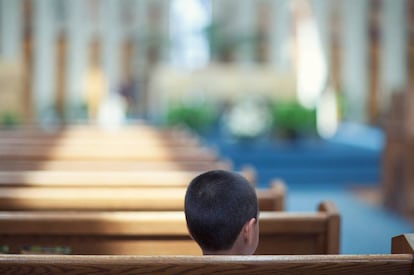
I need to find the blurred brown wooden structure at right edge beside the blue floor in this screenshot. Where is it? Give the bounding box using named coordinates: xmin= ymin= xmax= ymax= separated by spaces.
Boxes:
xmin=382 ymin=90 xmax=414 ymax=215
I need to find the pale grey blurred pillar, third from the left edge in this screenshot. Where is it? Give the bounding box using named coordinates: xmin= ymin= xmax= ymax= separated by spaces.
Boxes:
xmin=65 ymin=0 xmax=88 ymax=121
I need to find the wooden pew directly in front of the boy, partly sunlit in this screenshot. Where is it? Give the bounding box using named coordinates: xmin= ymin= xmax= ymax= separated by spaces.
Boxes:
xmin=0 ymin=202 xmax=340 ymax=255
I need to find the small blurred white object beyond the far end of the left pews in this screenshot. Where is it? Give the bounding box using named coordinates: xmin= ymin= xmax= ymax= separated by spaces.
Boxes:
xmin=97 ymin=94 xmax=126 ymax=130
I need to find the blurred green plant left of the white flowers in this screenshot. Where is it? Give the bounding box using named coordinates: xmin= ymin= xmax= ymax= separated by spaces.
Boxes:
xmin=166 ymin=104 xmax=216 ymax=132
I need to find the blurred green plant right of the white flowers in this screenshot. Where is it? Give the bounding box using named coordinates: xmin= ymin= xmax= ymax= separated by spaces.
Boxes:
xmin=272 ymin=102 xmax=316 ymax=138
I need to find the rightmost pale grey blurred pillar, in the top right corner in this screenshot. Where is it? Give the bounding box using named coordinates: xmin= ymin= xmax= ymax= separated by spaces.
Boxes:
xmin=379 ymin=0 xmax=408 ymax=112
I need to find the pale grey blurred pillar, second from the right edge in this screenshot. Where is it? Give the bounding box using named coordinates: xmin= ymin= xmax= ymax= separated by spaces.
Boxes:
xmin=341 ymin=0 xmax=368 ymax=123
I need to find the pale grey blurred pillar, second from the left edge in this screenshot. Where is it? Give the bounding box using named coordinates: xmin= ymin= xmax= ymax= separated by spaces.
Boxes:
xmin=32 ymin=0 xmax=56 ymax=125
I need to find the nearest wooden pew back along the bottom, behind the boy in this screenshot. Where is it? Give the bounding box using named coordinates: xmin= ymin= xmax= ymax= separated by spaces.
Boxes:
xmin=0 ymin=234 xmax=414 ymax=275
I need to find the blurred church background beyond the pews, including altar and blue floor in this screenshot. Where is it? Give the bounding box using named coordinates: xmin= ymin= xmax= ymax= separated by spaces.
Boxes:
xmin=0 ymin=0 xmax=414 ymax=253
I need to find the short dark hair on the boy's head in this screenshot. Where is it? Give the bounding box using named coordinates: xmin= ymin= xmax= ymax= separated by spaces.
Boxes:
xmin=184 ymin=170 xmax=258 ymax=251
